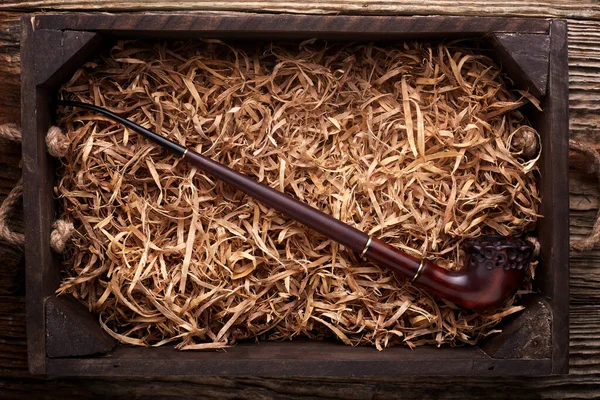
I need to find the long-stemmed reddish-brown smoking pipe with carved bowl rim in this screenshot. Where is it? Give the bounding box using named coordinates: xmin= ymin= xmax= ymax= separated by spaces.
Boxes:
xmin=57 ymin=100 xmax=533 ymax=312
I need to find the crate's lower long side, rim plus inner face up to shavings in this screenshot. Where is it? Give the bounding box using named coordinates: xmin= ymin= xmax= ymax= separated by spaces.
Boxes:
xmin=47 ymin=340 xmax=552 ymax=377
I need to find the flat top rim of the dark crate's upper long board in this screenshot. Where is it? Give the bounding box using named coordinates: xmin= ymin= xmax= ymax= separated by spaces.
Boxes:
xmin=31 ymin=12 xmax=551 ymax=40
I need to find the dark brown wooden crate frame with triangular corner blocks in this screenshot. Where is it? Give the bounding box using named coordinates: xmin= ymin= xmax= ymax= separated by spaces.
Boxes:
xmin=21 ymin=13 xmax=569 ymax=376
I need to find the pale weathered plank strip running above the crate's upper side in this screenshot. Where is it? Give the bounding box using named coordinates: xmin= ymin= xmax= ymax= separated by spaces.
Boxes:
xmin=0 ymin=0 xmax=600 ymax=19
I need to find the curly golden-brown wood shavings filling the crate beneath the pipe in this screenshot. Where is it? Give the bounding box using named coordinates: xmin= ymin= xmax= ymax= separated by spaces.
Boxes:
xmin=56 ymin=41 xmax=540 ymax=349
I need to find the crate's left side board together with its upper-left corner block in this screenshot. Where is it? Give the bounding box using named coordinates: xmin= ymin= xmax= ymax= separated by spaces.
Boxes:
xmin=21 ymin=17 xmax=112 ymax=374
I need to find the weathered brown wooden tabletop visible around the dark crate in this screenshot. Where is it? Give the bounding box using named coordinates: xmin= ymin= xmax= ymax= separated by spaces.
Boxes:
xmin=0 ymin=0 xmax=600 ymax=399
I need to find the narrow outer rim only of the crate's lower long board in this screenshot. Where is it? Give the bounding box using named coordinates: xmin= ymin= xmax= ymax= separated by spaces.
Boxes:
xmin=47 ymin=358 xmax=552 ymax=378
